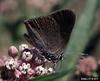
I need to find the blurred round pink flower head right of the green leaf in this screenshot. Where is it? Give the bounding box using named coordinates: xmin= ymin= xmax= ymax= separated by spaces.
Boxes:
xmin=76 ymin=56 xmax=97 ymax=76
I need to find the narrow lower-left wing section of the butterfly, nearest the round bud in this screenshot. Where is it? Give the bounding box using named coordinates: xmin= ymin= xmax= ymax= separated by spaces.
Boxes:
xmin=24 ymin=22 xmax=46 ymax=50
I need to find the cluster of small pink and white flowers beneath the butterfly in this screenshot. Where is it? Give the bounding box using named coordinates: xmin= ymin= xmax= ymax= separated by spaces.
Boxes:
xmin=0 ymin=44 xmax=54 ymax=81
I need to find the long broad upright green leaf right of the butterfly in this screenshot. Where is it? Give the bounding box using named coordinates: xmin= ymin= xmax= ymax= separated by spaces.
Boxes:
xmin=61 ymin=0 xmax=98 ymax=81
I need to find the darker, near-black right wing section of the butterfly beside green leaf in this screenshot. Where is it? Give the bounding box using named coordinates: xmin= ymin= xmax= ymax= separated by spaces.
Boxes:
xmin=51 ymin=9 xmax=75 ymax=54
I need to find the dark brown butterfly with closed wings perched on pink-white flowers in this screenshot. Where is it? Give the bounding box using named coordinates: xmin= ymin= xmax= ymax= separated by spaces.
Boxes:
xmin=24 ymin=10 xmax=75 ymax=62
